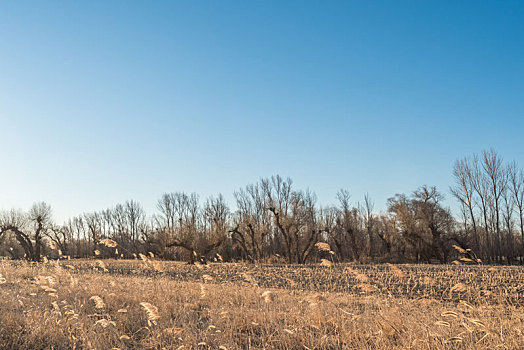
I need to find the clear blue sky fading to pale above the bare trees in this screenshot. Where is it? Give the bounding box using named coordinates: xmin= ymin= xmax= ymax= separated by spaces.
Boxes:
xmin=0 ymin=0 xmax=524 ymax=221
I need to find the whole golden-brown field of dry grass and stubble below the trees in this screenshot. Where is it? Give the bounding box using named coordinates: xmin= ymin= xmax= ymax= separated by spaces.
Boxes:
xmin=0 ymin=256 xmax=524 ymax=349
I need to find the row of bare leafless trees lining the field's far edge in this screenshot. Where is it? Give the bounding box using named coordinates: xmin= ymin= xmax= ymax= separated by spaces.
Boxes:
xmin=0 ymin=150 xmax=524 ymax=264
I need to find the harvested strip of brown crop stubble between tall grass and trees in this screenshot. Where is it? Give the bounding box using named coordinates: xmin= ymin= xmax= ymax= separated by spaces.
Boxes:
xmin=67 ymin=260 xmax=524 ymax=306
